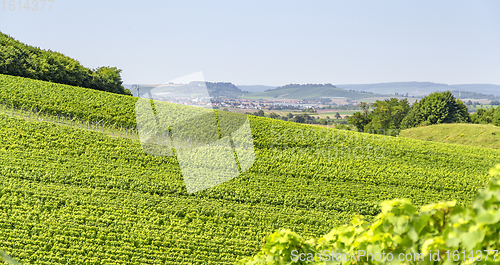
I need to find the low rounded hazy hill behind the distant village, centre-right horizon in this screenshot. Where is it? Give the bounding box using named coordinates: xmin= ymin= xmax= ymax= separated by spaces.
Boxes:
xmin=244 ymin=84 xmax=381 ymax=100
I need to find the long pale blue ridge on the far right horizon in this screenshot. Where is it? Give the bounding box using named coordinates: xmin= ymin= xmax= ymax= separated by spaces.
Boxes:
xmin=337 ymin=82 xmax=500 ymax=96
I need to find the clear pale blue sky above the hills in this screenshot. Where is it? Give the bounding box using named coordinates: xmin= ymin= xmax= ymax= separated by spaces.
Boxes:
xmin=0 ymin=0 xmax=500 ymax=85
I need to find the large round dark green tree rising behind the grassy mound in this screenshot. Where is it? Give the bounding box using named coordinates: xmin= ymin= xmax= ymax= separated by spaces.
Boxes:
xmin=401 ymin=91 xmax=470 ymax=128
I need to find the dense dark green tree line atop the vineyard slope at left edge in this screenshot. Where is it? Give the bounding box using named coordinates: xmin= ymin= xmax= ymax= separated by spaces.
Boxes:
xmin=0 ymin=32 xmax=131 ymax=95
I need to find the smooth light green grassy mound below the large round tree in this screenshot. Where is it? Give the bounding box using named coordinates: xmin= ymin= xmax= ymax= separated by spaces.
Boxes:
xmin=401 ymin=124 xmax=500 ymax=149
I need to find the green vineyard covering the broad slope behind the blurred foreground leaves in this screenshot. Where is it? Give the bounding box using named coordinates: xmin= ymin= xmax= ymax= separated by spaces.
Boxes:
xmin=0 ymin=75 xmax=500 ymax=264
